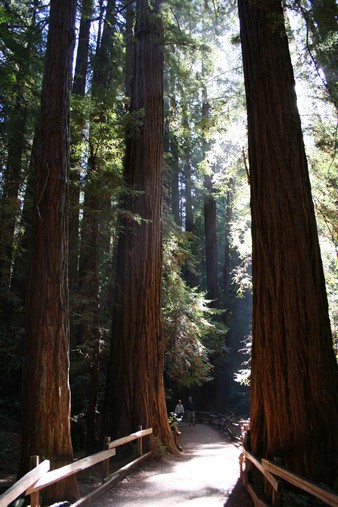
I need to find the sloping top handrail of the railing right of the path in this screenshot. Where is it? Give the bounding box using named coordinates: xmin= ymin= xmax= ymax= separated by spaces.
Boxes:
xmin=262 ymin=459 xmax=338 ymax=507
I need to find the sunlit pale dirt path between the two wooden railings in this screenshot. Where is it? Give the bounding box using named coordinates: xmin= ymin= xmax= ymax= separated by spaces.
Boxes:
xmin=93 ymin=423 xmax=252 ymax=507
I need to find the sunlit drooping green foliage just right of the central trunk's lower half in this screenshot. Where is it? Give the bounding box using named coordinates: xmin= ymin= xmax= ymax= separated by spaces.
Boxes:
xmin=162 ymin=220 xmax=217 ymax=387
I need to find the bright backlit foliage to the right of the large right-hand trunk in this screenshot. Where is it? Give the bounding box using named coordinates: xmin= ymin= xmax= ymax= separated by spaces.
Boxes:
xmin=289 ymin=0 xmax=338 ymax=358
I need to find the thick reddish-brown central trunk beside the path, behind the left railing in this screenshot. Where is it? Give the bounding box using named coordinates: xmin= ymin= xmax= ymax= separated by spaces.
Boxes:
xmin=103 ymin=0 xmax=174 ymax=451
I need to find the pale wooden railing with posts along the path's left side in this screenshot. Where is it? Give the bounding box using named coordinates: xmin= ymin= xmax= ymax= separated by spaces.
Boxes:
xmin=0 ymin=428 xmax=153 ymax=507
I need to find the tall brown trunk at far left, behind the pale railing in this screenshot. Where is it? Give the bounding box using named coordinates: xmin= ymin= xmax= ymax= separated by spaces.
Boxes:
xmin=20 ymin=0 xmax=78 ymax=501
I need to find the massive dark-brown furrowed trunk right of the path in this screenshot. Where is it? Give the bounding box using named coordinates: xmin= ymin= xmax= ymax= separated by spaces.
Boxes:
xmin=238 ymin=0 xmax=338 ymax=484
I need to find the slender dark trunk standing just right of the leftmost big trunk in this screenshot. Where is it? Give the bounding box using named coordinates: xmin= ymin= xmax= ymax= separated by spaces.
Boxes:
xmin=77 ymin=0 xmax=116 ymax=453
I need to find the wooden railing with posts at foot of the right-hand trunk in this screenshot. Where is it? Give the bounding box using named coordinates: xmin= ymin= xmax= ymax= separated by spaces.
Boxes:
xmin=240 ymin=449 xmax=338 ymax=507
